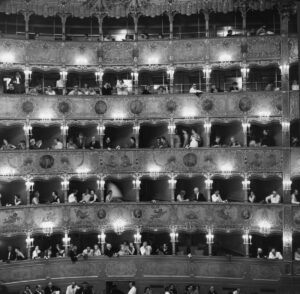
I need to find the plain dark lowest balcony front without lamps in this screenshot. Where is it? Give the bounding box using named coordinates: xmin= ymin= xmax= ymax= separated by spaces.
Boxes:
xmin=0 ymin=256 xmax=290 ymax=283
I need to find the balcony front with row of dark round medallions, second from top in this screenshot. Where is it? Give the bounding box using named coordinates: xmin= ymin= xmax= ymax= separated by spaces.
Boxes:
xmin=0 ymin=92 xmax=286 ymax=120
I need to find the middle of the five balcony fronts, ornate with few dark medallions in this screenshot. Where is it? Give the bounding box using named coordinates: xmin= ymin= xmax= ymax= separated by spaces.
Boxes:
xmin=0 ymin=148 xmax=284 ymax=178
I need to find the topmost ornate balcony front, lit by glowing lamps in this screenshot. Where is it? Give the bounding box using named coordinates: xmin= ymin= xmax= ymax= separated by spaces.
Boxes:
xmin=0 ymin=36 xmax=298 ymax=70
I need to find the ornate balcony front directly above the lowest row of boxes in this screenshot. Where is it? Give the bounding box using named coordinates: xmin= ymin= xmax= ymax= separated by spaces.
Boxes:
xmin=0 ymin=202 xmax=283 ymax=235
